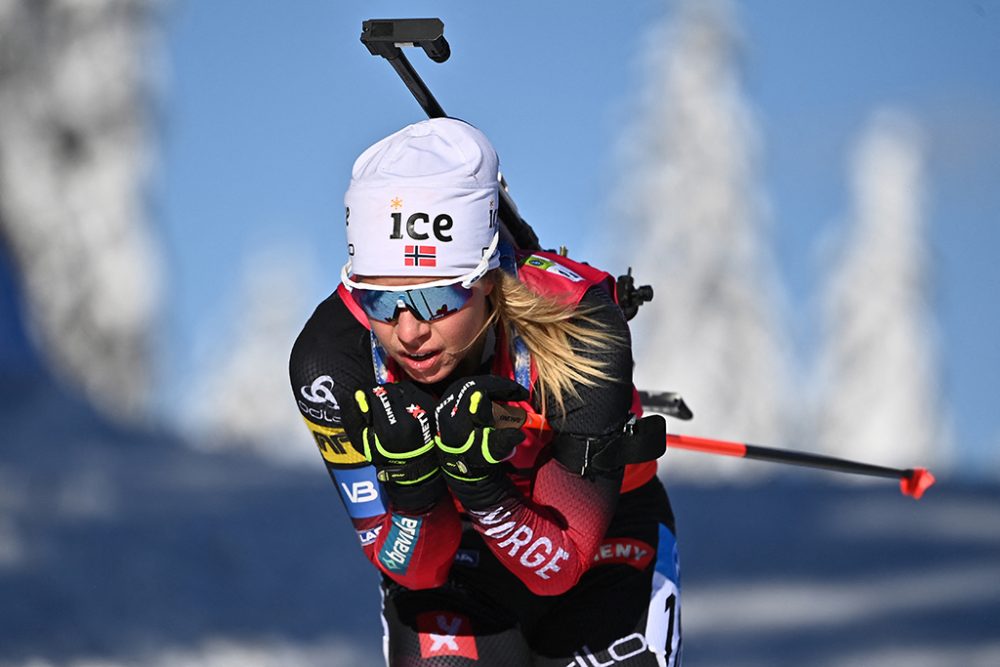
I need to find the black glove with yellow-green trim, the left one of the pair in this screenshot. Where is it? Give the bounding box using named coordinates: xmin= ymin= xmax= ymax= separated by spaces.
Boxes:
xmin=353 ymin=382 xmax=445 ymax=512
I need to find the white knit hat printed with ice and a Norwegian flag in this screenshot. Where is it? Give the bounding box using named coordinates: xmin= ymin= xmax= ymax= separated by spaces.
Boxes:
xmin=344 ymin=118 xmax=500 ymax=284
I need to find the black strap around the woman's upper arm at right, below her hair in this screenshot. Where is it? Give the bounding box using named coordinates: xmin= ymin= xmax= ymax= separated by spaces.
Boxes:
xmin=552 ymin=415 xmax=667 ymax=477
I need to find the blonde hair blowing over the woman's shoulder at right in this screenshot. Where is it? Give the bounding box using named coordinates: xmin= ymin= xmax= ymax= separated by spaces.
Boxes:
xmin=487 ymin=270 xmax=625 ymax=415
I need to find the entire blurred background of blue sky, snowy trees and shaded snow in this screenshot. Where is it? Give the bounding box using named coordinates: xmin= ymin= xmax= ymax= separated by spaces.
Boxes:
xmin=0 ymin=0 xmax=1000 ymax=667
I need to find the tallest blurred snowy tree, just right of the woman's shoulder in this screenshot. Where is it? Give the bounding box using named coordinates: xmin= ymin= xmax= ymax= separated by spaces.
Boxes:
xmin=609 ymin=2 xmax=796 ymax=474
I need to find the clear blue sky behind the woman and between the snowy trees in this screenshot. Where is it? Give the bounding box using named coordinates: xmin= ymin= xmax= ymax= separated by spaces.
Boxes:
xmin=153 ymin=0 xmax=1000 ymax=470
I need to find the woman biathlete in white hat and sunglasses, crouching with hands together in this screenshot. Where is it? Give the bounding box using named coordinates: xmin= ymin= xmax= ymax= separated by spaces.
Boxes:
xmin=290 ymin=118 xmax=681 ymax=667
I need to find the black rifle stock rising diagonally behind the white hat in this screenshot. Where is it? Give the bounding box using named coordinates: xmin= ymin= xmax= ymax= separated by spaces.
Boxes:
xmin=361 ymin=19 xmax=541 ymax=250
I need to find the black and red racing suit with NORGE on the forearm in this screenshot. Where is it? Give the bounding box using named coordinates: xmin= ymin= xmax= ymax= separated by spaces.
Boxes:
xmin=290 ymin=253 xmax=680 ymax=665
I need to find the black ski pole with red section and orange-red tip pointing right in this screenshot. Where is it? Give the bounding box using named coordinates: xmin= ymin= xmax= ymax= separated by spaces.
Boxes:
xmin=493 ymin=404 xmax=934 ymax=500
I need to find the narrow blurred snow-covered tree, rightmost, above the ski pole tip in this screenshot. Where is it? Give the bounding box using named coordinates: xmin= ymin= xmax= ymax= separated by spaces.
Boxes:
xmin=816 ymin=110 xmax=950 ymax=465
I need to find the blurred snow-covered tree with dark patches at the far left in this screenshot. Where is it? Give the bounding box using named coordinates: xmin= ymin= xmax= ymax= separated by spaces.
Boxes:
xmin=0 ymin=0 xmax=160 ymax=416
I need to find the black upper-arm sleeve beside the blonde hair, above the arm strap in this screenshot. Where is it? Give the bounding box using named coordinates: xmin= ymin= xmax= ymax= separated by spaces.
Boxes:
xmin=547 ymin=287 xmax=632 ymax=437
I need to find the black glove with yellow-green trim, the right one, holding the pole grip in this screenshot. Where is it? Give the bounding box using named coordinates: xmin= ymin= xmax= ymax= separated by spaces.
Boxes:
xmin=434 ymin=375 xmax=529 ymax=509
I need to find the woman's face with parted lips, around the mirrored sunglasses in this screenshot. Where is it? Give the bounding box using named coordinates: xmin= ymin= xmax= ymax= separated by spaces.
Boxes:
xmin=364 ymin=277 xmax=493 ymax=384
